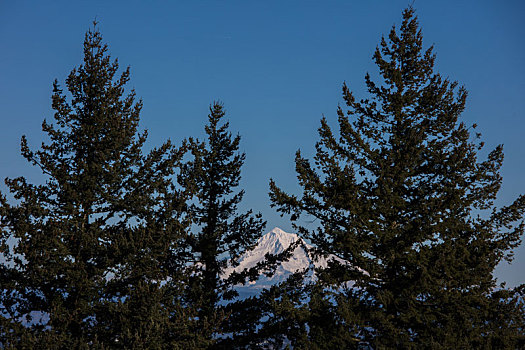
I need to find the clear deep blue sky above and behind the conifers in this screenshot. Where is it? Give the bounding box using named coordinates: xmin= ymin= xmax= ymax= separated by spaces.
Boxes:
xmin=0 ymin=0 xmax=525 ymax=285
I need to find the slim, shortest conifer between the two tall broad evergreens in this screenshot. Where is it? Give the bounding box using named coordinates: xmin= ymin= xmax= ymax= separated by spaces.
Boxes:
xmin=179 ymin=102 xmax=265 ymax=340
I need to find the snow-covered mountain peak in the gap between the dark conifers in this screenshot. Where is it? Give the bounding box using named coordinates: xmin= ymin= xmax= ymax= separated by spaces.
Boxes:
xmin=224 ymin=227 xmax=340 ymax=297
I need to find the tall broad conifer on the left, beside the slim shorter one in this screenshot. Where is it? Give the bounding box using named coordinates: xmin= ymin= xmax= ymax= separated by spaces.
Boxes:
xmin=0 ymin=23 xmax=200 ymax=349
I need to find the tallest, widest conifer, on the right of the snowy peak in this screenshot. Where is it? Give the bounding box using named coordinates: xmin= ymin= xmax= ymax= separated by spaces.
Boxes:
xmin=270 ymin=8 xmax=525 ymax=348
